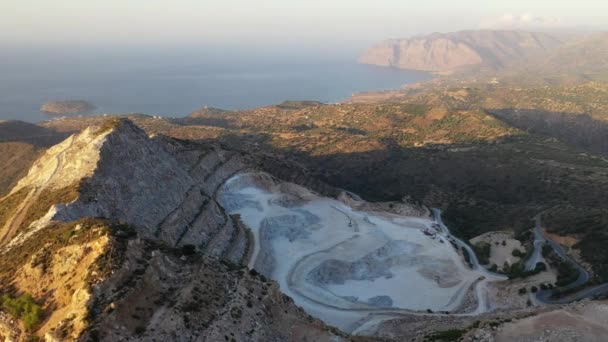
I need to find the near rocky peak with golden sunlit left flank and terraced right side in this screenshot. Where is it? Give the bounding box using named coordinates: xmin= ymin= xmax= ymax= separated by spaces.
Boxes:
xmin=0 ymin=119 xmax=352 ymax=341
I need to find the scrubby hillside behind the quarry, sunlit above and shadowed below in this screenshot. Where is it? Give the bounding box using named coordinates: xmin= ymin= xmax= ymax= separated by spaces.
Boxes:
xmin=166 ymin=90 xmax=608 ymax=280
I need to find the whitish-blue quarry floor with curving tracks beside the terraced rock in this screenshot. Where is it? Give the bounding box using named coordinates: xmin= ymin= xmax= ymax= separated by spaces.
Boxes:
xmin=219 ymin=173 xmax=504 ymax=331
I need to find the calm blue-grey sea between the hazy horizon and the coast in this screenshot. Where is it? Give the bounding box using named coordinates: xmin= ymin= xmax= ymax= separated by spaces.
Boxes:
xmin=0 ymin=52 xmax=430 ymax=122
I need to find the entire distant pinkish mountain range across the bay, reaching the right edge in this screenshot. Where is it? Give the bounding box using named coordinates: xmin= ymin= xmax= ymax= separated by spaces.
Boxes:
xmin=359 ymin=30 xmax=608 ymax=72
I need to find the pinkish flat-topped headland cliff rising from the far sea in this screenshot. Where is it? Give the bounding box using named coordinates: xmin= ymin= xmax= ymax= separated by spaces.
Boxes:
xmin=359 ymin=31 xmax=562 ymax=71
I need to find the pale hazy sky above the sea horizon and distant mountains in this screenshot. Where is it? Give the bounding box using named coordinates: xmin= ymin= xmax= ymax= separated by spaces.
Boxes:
xmin=0 ymin=0 xmax=608 ymax=49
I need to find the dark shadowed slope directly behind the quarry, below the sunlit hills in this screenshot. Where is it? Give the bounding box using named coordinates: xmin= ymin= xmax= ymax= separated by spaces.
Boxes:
xmin=195 ymin=133 xmax=608 ymax=242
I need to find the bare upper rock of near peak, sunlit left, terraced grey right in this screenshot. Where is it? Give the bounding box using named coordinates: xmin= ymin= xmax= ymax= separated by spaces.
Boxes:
xmin=5 ymin=121 xmax=246 ymax=257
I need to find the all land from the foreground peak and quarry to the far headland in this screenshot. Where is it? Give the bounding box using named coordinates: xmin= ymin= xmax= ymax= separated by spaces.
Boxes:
xmin=0 ymin=25 xmax=608 ymax=342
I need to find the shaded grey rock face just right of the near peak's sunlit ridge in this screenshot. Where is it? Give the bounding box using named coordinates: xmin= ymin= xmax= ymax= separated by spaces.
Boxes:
xmin=59 ymin=120 xmax=195 ymax=236
